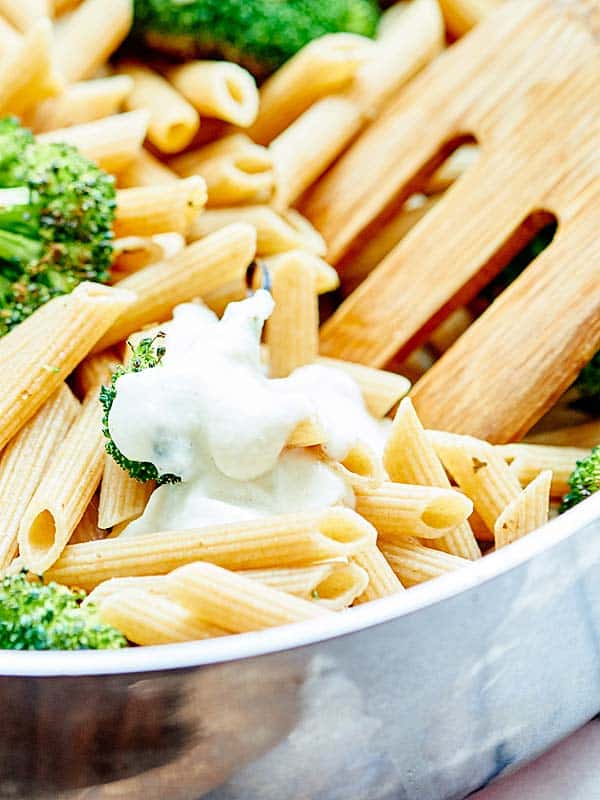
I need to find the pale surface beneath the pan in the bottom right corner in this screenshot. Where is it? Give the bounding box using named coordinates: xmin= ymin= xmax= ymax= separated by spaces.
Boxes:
xmin=471 ymin=720 xmax=600 ymax=800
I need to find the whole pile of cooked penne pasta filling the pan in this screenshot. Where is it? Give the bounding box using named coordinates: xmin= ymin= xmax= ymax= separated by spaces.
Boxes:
xmin=0 ymin=0 xmax=600 ymax=645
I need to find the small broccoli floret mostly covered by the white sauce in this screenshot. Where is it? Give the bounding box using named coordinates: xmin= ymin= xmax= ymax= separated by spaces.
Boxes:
xmin=100 ymin=333 xmax=181 ymax=484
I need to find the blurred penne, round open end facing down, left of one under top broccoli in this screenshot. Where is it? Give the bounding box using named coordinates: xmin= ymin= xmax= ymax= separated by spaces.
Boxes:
xmin=119 ymin=61 xmax=200 ymax=153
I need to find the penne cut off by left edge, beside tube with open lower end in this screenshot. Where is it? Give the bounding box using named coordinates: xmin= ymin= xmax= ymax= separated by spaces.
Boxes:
xmin=0 ymin=383 xmax=79 ymax=574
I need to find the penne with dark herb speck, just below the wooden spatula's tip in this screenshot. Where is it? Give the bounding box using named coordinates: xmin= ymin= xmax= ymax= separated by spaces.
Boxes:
xmin=428 ymin=431 xmax=521 ymax=530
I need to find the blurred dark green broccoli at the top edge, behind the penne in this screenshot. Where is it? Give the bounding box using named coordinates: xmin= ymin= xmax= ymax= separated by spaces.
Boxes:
xmin=133 ymin=0 xmax=379 ymax=77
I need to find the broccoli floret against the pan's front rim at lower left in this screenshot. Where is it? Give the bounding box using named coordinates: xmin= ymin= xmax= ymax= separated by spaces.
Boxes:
xmin=0 ymin=572 xmax=127 ymax=650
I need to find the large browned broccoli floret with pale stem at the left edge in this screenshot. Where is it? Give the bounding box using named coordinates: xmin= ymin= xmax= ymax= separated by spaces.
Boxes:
xmin=0 ymin=117 xmax=116 ymax=336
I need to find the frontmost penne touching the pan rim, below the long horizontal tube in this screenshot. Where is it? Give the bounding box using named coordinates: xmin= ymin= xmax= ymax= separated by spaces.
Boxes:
xmin=167 ymin=562 xmax=330 ymax=633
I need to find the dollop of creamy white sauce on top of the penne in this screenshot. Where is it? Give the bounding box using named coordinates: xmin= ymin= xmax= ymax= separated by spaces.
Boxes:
xmin=108 ymin=290 xmax=383 ymax=535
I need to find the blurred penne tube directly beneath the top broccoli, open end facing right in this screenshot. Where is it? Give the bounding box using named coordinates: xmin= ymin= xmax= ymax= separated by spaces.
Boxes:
xmin=167 ymin=61 xmax=258 ymax=128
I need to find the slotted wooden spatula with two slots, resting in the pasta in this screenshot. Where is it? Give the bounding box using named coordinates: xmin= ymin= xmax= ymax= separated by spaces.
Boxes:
xmin=303 ymin=0 xmax=600 ymax=442
